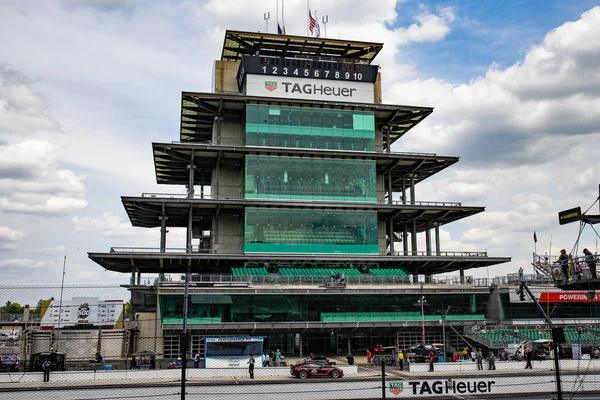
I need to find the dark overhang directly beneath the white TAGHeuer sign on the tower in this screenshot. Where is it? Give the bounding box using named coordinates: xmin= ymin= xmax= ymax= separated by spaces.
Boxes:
xmin=180 ymin=92 xmax=433 ymax=144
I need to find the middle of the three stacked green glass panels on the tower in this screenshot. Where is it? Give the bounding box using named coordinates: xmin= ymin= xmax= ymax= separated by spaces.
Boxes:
xmin=244 ymin=155 xmax=377 ymax=202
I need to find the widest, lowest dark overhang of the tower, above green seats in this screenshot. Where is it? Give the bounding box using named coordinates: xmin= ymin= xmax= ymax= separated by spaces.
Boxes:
xmin=88 ymin=251 xmax=511 ymax=275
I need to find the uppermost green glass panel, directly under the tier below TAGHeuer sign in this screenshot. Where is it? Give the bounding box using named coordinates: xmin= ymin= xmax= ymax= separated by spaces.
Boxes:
xmin=245 ymin=104 xmax=375 ymax=151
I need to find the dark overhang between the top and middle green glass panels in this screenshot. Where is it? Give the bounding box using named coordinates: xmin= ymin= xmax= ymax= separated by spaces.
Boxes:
xmin=152 ymin=143 xmax=459 ymax=192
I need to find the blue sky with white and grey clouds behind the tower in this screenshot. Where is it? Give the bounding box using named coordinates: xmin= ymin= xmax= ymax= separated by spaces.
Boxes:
xmin=0 ymin=0 xmax=600 ymax=290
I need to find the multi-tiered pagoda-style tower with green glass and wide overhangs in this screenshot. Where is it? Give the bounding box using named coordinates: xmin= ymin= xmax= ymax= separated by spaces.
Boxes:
xmin=89 ymin=31 xmax=510 ymax=357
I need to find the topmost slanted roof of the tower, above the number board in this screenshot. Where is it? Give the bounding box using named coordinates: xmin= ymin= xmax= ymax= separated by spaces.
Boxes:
xmin=221 ymin=30 xmax=383 ymax=64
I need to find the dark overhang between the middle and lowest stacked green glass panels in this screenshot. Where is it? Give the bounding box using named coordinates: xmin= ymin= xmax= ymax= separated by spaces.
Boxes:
xmin=121 ymin=195 xmax=485 ymax=232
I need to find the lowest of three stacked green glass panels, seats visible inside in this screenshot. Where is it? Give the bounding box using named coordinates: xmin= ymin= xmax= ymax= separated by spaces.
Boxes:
xmin=244 ymin=208 xmax=378 ymax=254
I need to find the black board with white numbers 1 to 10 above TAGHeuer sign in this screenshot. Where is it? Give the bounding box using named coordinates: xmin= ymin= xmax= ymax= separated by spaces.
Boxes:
xmin=237 ymin=56 xmax=379 ymax=90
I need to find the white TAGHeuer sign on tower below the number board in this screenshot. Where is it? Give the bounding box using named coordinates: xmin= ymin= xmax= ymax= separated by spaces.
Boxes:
xmin=246 ymin=74 xmax=374 ymax=104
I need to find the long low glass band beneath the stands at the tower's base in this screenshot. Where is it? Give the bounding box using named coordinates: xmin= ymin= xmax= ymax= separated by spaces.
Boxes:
xmin=160 ymin=293 xmax=488 ymax=324
